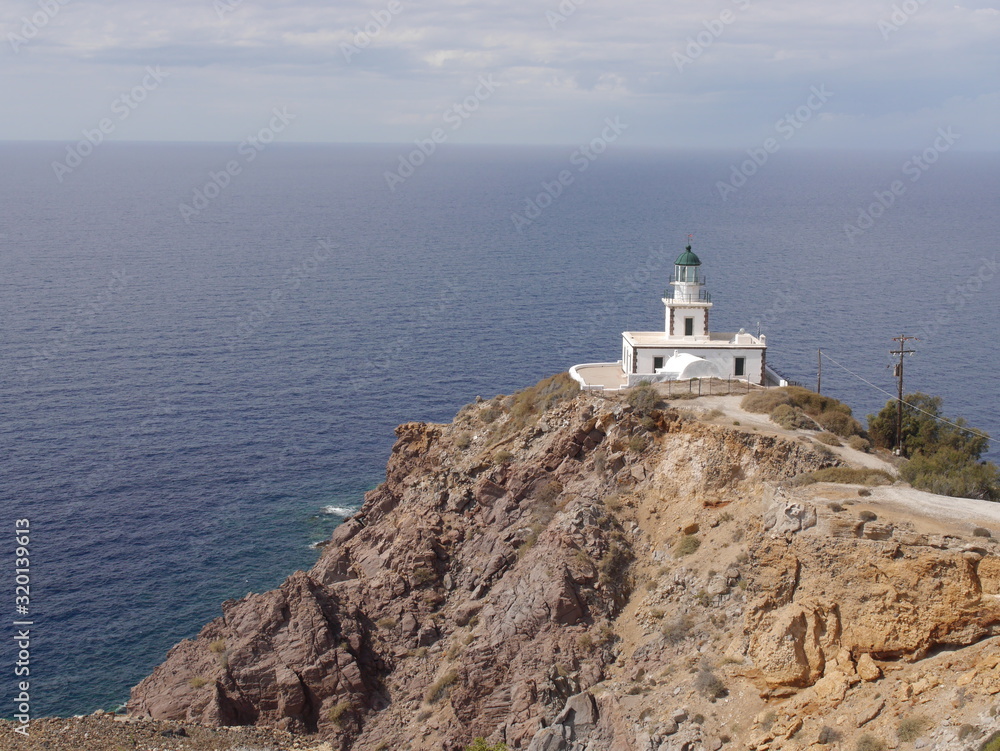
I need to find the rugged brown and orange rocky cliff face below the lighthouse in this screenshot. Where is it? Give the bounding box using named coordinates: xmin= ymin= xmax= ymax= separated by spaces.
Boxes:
xmin=128 ymin=376 xmax=1000 ymax=751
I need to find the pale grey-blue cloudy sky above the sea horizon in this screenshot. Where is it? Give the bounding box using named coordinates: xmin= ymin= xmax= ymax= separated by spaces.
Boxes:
xmin=0 ymin=0 xmax=1000 ymax=151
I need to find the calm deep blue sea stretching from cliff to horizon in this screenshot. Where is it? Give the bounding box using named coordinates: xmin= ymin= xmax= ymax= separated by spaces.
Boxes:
xmin=0 ymin=143 xmax=1000 ymax=716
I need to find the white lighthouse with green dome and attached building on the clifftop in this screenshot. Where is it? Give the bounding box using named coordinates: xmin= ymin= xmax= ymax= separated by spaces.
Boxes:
xmin=570 ymin=245 xmax=780 ymax=390
